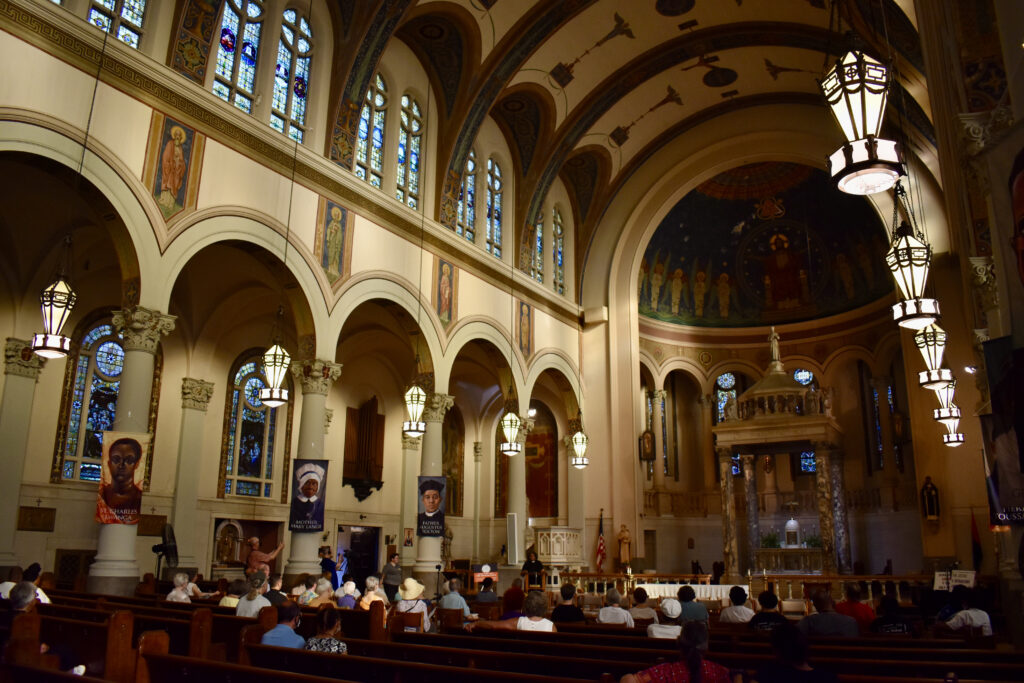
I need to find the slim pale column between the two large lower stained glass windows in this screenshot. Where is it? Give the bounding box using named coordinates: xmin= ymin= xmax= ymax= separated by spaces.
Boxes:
xmin=172 ymin=377 xmax=213 ymax=567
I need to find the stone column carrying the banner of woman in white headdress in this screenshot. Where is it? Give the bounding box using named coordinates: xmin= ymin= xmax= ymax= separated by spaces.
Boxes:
xmin=285 ymin=358 xmax=341 ymax=577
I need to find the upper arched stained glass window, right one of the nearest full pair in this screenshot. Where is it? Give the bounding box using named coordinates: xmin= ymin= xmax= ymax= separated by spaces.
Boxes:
xmin=270 ymin=9 xmax=313 ymax=142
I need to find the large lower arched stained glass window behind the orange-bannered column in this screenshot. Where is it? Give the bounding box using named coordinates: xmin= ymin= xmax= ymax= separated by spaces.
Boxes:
xmin=50 ymin=317 xmax=163 ymax=485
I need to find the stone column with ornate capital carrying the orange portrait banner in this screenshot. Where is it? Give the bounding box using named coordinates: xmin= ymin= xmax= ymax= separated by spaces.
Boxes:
xmin=86 ymin=306 xmax=175 ymax=595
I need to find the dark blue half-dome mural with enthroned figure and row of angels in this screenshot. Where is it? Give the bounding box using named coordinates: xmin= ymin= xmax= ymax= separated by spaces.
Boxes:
xmin=637 ymin=162 xmax=892 ymax=327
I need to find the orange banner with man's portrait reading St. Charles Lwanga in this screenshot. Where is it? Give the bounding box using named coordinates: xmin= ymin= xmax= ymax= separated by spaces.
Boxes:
xmin=96 ymin=431 xmax=151 ymax=524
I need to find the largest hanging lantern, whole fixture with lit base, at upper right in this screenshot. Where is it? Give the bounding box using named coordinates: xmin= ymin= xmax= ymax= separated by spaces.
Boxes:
xmin=821 ymin=50 xmax=903 ymax=195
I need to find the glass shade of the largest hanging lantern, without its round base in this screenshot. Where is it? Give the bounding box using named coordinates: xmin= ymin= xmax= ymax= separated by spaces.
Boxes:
xmin=821 ymin=50 xmax=889 ymax=142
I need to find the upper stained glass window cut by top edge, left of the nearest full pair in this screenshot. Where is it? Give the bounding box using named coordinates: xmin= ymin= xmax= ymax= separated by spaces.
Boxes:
xmin=213 ymin=0 xmax=263 ymax=114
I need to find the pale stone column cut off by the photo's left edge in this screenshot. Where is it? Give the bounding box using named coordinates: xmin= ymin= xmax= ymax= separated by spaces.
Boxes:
xmin=0 ymin=337 xmax=46 ymax=566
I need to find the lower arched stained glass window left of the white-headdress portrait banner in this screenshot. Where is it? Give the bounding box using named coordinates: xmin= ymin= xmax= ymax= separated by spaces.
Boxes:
xmin=217 ymin=353 xmax=292 ymax=498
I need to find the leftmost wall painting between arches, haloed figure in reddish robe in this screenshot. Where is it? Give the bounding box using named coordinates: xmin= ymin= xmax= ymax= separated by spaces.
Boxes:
xmin=142 ymin=112 xmax=206 ymax=221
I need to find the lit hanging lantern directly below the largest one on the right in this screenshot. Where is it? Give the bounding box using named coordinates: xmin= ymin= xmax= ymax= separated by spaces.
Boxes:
xmin=886 ymin=221 xmax=939 ymax=330
